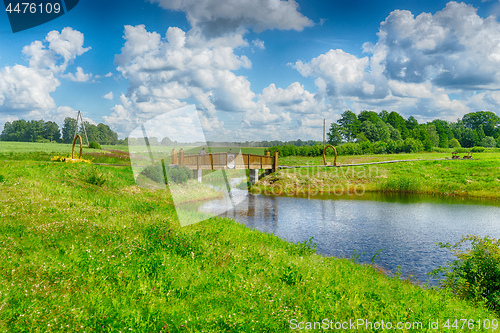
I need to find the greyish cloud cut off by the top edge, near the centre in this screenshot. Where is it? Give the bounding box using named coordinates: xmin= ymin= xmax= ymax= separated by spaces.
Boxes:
xmin=150 ymin=0 xmax=313 ymax=36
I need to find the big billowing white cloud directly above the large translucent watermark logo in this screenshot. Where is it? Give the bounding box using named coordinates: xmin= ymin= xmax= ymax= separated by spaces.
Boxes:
xmin=106 ymin=25 xmax=257 ymax=133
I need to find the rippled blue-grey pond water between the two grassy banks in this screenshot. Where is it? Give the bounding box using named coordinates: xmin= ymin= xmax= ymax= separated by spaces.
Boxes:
xmin=200 ymin=191 xmax=500 ymax=284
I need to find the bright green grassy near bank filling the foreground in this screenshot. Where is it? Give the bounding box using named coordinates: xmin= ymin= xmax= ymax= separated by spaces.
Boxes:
xmin=0 ymin=143 xmax=498 ymax=332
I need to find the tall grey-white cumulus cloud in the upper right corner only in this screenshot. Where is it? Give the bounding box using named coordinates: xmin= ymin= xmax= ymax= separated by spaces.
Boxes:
xmin=373 ymin=1 xmax=500 ymax=90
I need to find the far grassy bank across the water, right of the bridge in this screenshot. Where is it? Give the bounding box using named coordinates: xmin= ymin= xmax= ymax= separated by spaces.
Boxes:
xmin=251 ymin=153 xmax=500 ymax=200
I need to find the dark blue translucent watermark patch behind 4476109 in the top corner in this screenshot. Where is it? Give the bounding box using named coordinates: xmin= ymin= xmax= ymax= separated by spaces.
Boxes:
xmin=3 ymin=0 xmax=79 ymax=32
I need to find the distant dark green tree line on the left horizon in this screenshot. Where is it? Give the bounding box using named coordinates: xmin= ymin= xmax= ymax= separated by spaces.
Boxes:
xmin=0 ymin=117 xmax=121 ymax=145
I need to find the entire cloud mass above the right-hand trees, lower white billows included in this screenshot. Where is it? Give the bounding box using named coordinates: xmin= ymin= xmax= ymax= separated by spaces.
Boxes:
xmin=294 ymin=1 xmax=500 ymax=120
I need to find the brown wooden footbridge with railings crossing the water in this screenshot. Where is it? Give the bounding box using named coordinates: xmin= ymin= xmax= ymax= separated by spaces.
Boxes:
xmin=171 ymin=148 xmax=279 ymax=184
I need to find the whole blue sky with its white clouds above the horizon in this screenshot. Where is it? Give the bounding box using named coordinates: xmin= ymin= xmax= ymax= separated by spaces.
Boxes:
xmin=0 ymin=0 xmax=500 ymax=141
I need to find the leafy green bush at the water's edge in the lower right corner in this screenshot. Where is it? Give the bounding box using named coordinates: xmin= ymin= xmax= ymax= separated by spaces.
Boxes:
xmin=431 ymin=235 xmax=500 ymax=313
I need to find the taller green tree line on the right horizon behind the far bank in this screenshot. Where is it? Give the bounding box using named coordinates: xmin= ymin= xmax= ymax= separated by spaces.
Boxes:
xmin=328 ymin=110 xmax=500 ymax=151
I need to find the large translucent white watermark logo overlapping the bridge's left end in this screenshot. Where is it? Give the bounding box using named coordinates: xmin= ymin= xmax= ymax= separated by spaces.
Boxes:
xmin=128 ymin=106 xmax=248 ymax=226
